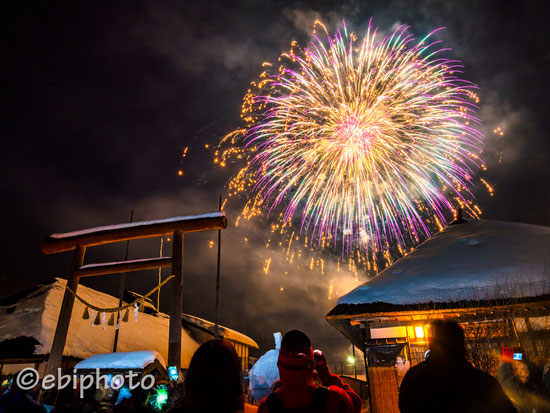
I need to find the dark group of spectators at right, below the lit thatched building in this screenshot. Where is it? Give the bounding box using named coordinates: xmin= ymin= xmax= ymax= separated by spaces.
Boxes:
xmin=399 ymin=320 xmax=550 ymax=413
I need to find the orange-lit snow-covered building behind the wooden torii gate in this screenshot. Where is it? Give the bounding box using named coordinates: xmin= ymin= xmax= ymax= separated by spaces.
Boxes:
xmin=0 ymin=278 xmax=258 ymax=374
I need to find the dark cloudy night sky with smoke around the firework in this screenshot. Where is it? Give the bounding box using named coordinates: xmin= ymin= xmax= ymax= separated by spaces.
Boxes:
xmin=0 ymin=0 xmax=550 ymax=360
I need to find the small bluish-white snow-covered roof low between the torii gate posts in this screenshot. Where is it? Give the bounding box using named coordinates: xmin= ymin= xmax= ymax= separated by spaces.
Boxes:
xmin=74 ymin=350 xmax=166 ymax=370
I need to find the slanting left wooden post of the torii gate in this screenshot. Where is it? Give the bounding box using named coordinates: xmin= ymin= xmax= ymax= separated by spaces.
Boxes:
xmin=45 ymin=244 xmax=86 ymax=375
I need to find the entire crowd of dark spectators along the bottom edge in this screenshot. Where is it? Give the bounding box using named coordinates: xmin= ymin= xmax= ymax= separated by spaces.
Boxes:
xmin=0 ymin=320 xmax=550 ymax=413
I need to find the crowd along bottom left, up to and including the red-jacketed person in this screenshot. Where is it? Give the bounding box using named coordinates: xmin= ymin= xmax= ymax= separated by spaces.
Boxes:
xmin=0 ymin=330 xmax=362 ymax=413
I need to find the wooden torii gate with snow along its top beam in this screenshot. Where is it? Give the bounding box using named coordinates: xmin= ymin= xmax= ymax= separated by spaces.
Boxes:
xmin=42 ymin=212 xmax=227 ymax=375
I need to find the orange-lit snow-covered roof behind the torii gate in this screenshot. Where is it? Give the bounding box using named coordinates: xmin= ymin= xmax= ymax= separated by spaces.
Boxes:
xmin=0 ymin=278 xmax=200 ymax=368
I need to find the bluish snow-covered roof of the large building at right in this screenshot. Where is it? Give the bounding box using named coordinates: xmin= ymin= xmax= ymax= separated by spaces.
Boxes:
xmin=329 ymin=220 xmax=550 ymax=316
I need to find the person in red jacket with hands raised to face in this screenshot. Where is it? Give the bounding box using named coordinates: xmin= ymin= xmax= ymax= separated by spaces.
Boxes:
xmin=258 ymin=330 xmax=362 ymax=413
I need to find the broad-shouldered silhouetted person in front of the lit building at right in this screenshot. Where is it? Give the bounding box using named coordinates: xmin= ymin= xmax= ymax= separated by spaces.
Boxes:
xmin=399 ymin=320 xmax=516 ymax=413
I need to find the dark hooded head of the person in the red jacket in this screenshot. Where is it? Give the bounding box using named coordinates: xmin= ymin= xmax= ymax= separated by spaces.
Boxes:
xmin=277 ymin=330 xmax=315 ymax=385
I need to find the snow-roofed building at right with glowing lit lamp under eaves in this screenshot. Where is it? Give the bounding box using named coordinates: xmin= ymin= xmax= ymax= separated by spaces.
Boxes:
xmin=327 ymin=220 xmax=550 ymax=364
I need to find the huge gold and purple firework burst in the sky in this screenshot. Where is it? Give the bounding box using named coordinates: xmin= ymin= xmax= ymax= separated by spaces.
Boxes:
xmin=222 ymin=20 xmax=482 ymax=270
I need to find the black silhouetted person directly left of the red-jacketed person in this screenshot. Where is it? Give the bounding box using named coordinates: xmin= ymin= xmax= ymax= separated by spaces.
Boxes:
xmin=172 ymin=340 xmax=244 ymax=413
